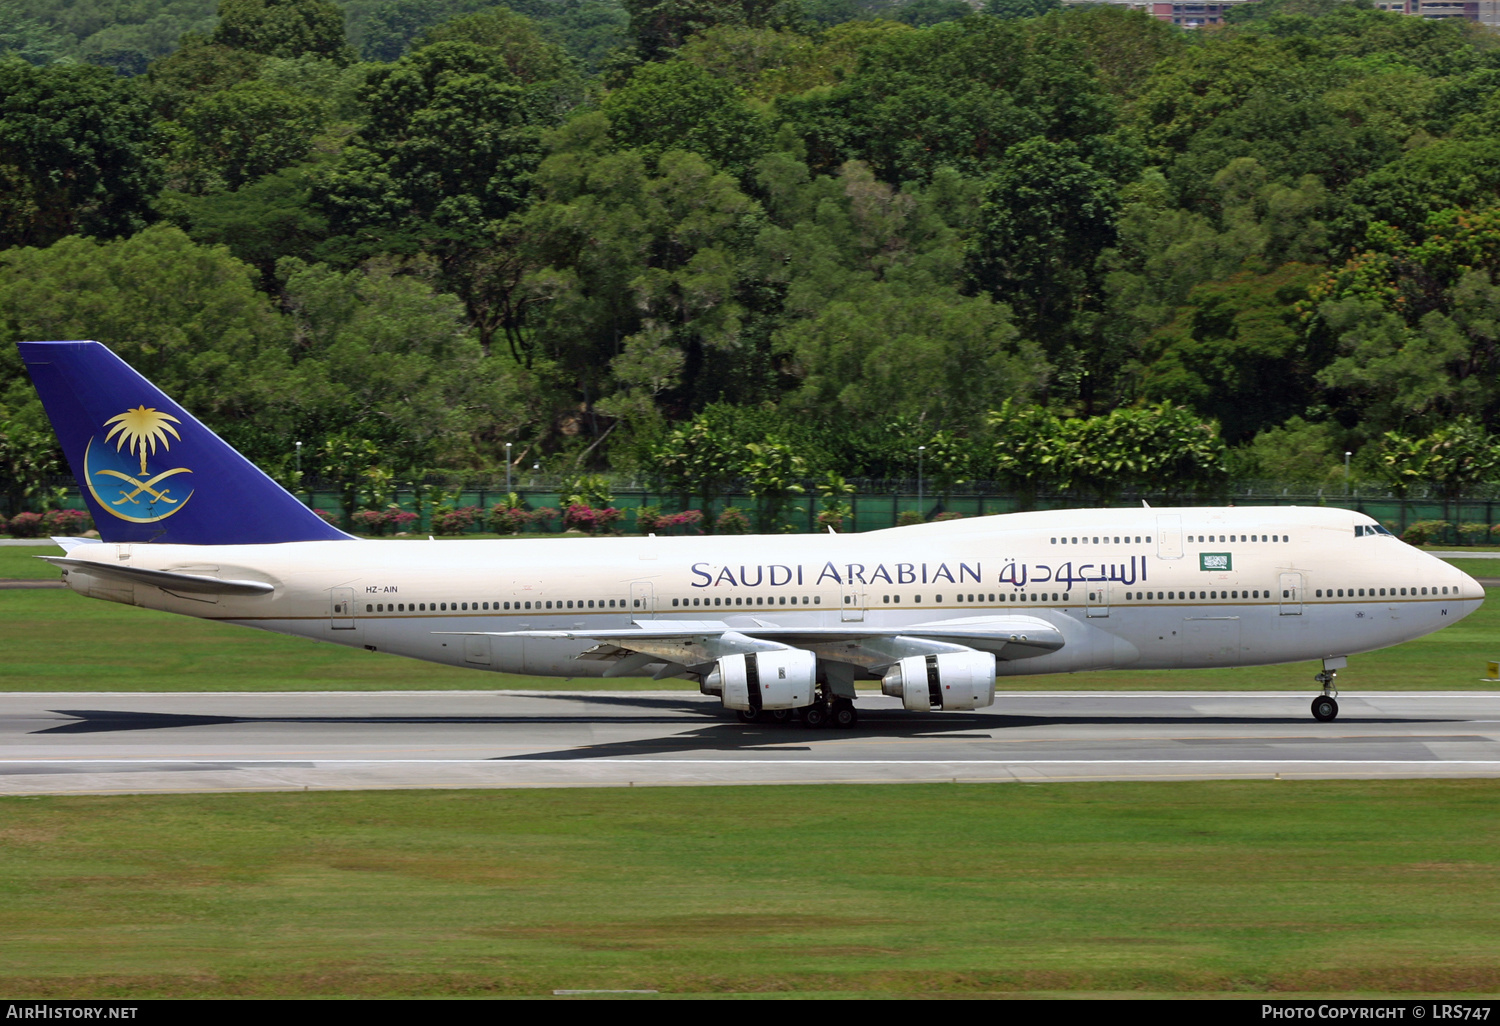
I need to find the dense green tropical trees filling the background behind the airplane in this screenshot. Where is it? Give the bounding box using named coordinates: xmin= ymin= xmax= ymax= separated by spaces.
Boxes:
xmin=0 ymin=0 xmax=1500 ymax=507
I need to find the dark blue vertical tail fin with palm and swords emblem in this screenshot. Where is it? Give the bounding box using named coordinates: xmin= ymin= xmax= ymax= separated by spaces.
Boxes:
xmin=20 ymin=342 xmax=350 ymax=545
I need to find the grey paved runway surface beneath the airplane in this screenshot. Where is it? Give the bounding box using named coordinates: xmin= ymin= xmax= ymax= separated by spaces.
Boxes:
xmin=0 ymin=692 xmax=1500 ymax=795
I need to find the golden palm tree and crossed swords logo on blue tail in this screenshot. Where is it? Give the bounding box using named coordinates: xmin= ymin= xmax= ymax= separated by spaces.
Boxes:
xmin=84 ymin=404 xmax=192 ymax=524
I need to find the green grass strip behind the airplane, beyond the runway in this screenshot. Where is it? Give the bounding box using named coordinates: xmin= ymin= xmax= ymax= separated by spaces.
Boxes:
xmin=0 ymin=546 xmax=1500 ymax=692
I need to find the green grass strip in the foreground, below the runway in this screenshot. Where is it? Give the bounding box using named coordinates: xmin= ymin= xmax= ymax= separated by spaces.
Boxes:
xmin=0 ymin=780 xmax=1500 ymax=998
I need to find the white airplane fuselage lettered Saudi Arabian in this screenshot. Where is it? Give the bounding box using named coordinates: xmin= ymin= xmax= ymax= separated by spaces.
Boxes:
xmin=52 ymin=507 xmax=1484 ymax=677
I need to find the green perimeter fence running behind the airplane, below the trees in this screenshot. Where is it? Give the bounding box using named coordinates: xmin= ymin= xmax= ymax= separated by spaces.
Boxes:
xmin=17 ymin=488 xmax=1500 ymax=545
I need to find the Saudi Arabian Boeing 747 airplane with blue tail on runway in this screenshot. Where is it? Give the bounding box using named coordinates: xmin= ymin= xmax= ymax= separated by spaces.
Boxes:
xmin=21 ymin=342 xmax=1484 ymax=726
